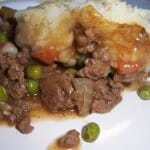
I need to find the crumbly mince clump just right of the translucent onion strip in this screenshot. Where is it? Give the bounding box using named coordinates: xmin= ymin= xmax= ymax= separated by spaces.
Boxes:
xmin=91 ymin=78 xmax=123 ymax=113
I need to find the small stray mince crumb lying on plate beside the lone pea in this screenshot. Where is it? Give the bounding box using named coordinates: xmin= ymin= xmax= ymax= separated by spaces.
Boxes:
xmin=57 ymin=129 xmax=80 ymax=148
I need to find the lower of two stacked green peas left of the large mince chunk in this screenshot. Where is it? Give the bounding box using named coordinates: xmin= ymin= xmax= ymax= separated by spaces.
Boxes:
xmin=26 ymin=79 xmax=39 ymax=94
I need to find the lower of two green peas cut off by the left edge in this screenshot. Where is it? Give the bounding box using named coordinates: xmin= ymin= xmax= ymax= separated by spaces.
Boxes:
xmin=0 ymin=85 xmax=8 ymax=102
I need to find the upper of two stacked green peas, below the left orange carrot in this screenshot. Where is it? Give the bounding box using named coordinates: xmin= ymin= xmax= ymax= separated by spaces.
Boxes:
xmin=26 ymin=65 xmax=42 ymax=80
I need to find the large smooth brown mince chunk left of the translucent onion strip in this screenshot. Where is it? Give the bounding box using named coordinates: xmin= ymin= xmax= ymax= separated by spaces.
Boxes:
xmin=40 ymin=71 xmax=74 ymax=112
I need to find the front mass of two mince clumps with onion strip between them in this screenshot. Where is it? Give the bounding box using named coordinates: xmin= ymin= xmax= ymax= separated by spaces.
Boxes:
xmin=40 ymin=71 xmax=123 ymax=116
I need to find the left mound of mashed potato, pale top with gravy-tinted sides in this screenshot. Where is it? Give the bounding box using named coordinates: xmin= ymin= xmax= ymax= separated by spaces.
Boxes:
xmin=16 ymin=0 xmax=76 ymax=63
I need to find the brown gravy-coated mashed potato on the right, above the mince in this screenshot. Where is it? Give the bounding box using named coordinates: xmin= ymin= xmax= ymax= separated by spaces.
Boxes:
xmin=72 ymin=6 xmax=150 ymax=73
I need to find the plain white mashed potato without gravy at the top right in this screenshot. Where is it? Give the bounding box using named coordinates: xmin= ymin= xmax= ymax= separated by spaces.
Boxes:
xmin=84 ymin=0 xmax=150 ymax=33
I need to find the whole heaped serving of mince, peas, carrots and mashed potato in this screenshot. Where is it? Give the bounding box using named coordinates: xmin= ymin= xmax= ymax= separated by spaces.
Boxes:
xmin=0 ymin=0 xmax=150 ymax=133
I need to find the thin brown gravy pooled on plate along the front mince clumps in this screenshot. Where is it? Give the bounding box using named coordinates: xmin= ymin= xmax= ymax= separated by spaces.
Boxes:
xmin=0 ymin=96 xmax=79 ymax=126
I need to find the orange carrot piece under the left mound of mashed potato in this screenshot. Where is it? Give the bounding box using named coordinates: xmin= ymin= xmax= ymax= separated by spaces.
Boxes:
xmin=32 ymin=47 xmax=58 ymax=65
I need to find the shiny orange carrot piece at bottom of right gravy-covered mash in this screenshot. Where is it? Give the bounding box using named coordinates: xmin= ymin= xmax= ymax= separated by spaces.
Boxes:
xmin=117 ymin=60 xmax=141 ymax=74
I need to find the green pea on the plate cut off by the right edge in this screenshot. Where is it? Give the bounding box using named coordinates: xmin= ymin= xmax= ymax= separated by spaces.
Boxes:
xmin=137 ymin=85 xmax=150 ymax=100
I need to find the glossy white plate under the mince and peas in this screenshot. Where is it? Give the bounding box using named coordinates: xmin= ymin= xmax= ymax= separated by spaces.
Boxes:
xmin=0 ymin=0 xmax=150 ymax=150
